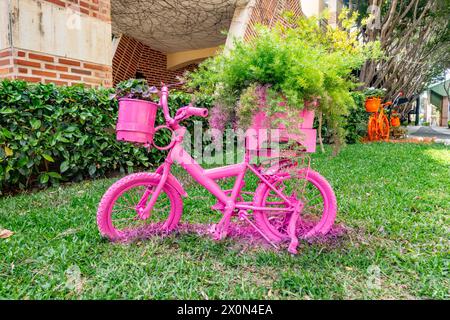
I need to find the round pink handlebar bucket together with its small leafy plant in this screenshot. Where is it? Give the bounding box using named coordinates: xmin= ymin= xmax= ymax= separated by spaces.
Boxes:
xmin=111 ymin=79 xmax=158 ymax=145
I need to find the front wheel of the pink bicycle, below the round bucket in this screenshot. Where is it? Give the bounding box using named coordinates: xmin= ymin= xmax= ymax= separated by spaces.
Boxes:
xmin=97 ymin=172 xmax=183 ymax=240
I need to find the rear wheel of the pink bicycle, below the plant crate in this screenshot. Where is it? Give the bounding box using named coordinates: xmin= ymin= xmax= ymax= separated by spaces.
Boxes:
xmin=254 ymin=169 xmax=337 ymax=242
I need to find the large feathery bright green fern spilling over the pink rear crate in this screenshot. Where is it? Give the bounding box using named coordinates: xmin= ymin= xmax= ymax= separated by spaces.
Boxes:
xmin=188 ymin=11 xmax=380 ymax=153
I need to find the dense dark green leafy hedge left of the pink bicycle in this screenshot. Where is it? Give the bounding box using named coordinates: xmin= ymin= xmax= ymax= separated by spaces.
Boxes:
xmin=0 ymin=80 xmax=210 ymax=194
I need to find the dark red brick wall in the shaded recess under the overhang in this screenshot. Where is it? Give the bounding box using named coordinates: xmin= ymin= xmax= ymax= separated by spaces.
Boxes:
xmin=113 ymin=36 xmax=197 ymax=85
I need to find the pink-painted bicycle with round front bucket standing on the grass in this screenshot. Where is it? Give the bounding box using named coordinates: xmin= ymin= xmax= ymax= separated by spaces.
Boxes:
xmin=97 ymin=86 xmax=337 ymax=254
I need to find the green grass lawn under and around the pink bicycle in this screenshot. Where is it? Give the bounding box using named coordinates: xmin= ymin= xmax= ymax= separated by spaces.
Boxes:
xmin=0 ymin=144 xmax=450 ymax=299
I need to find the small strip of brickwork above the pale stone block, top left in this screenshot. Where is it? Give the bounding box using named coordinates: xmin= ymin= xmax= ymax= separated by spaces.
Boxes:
xmin=43 ymin=0 xmax=111 ymax=21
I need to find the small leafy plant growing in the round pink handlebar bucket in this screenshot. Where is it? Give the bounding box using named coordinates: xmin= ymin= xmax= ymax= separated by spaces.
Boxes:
xmin=110 ymin=79 xmax=158 ymax=101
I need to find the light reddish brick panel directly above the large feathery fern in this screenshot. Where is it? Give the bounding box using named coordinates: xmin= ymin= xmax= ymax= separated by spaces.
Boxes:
xmin=244 ymin=0 xmax=303 ymax=40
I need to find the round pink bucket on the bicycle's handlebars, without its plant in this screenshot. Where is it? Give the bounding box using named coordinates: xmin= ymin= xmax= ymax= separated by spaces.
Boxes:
xmin=116 ymin=99 xmax=158 ymax=145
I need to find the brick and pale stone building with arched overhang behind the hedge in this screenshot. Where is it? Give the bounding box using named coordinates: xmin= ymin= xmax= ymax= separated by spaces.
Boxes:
xmin=0 ymin=0 xmax=342 ymax=87
